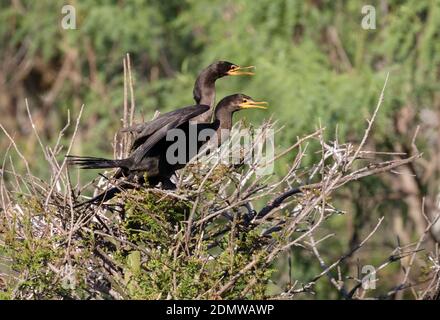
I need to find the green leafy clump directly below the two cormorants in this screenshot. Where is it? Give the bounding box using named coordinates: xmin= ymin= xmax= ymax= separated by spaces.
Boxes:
xmin=115 ymin=191 xmax=272 ymax=299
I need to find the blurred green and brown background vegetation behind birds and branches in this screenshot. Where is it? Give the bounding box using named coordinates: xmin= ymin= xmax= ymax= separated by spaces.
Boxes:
xmin=0 ymin=0 xmax=440 ymax=296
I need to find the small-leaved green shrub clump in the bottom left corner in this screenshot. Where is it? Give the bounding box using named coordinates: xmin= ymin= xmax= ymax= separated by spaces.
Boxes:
xmin=0 ymin=198 xmax=89 ymax=299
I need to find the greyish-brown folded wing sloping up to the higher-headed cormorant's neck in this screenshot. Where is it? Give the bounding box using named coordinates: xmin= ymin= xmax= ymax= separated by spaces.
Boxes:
xmin=130 ymin=105 xmax=209 ymax=163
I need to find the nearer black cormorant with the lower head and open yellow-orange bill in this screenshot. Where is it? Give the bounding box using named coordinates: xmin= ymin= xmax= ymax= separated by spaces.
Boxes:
xmin=68 ymin=94 xmax=267 ymax=206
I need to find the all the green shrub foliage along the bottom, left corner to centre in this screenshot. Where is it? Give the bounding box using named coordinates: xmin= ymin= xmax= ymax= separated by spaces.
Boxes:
xmin=0 ymin=191 xmax=273 ymax=299
